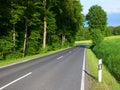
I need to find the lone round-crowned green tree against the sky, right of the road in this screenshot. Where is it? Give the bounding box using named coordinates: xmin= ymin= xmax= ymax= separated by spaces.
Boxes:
xmin=86 ymin=5 xmax=107 ymax=44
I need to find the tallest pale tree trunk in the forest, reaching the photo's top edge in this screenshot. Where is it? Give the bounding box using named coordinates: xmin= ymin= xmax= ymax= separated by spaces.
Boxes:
xmin=43 ymin=0 xmax=47 ymax=48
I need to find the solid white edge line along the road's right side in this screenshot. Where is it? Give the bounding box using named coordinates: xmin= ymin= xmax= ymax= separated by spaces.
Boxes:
xmin=80 ymin=49 xmax=86 ymax=90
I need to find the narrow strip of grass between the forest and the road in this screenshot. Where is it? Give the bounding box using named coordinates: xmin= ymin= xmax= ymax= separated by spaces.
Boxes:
xmin=0 ymin=48 xmax=67 ymax=67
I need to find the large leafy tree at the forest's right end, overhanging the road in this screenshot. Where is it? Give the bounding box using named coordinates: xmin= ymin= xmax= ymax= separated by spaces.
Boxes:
xmin=55 ymin=0 xmax=83 ymax=47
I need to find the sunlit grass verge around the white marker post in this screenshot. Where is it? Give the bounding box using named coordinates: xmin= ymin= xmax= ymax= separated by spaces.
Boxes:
xmin=87 ymin=49 xmax=120 ymax=90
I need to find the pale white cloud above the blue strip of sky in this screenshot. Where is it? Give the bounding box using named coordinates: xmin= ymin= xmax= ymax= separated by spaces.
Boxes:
xmin=80 ymin=0 xmax=120 ymax=14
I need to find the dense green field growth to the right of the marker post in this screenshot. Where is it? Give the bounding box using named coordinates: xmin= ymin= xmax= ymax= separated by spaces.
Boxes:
xmin=93 ymin=39 xmax=120 ymax=82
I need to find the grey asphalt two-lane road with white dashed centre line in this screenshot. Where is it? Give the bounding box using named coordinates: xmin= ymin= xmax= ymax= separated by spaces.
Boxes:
xmin=0 ymin=47 xmax=85 ymax=90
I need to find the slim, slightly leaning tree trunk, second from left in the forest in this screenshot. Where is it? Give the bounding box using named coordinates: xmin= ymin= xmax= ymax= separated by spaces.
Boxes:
xmin=23 ymin=19 xmax=28 ymax=57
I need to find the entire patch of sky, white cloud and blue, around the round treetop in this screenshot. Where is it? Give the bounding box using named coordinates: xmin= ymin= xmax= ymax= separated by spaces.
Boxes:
xmin=80 ymin=0 xmax=120 ymax=26
